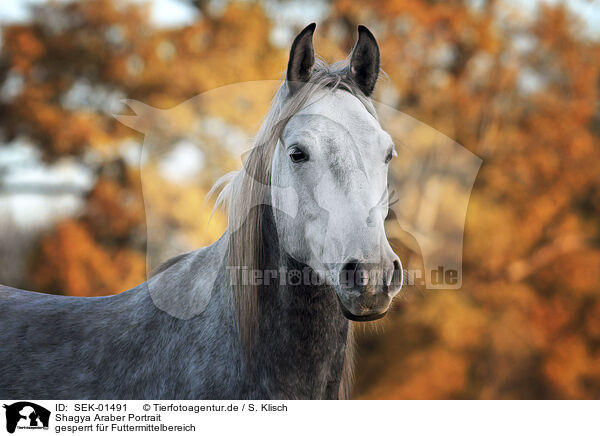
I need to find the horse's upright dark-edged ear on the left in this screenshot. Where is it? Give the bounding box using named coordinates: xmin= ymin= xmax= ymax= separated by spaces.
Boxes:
xmin=286 ymin=23 xmax=317 ymax=94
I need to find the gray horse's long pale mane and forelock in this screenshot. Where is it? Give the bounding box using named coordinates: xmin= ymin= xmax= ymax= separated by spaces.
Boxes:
xmin=211 ymin=58 xmax=377 ymax=372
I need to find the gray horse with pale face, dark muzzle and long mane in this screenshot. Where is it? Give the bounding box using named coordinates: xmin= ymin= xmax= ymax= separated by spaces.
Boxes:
xmin=0 ymin=24 xmax=402 ymax=399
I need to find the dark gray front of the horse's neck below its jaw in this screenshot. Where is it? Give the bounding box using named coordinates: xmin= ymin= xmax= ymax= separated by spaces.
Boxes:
xmin=248 ymin=206 xmax=349 ymax=398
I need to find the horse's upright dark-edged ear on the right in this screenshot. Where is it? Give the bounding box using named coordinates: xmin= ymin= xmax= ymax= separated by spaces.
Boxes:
xmin=350 ymin=25 xmax=379 ymax=97
